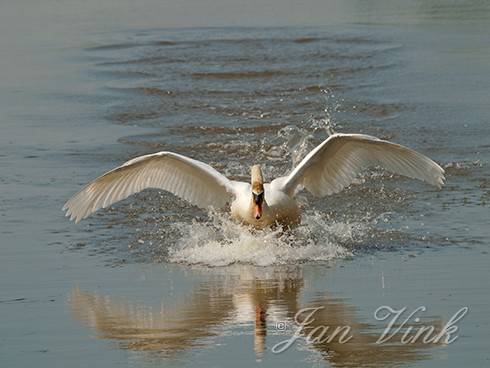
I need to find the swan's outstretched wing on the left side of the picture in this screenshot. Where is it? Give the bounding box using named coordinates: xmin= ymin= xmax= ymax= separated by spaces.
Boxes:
xmin=63 ymin=152 xmax=238 ymax=222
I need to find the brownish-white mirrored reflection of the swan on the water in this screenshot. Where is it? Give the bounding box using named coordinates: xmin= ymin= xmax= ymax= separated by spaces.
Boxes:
xmin=68 ymin=266 xmax=442 ymax=367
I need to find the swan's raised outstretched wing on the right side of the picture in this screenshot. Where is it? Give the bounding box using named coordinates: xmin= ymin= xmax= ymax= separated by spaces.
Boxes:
xmin=272 ymin=134 xmax=444 ymax=197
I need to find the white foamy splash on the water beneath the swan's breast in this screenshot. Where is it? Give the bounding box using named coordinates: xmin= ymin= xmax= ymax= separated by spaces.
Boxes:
xmin=168 ymin=213 xmax=363 ymax=266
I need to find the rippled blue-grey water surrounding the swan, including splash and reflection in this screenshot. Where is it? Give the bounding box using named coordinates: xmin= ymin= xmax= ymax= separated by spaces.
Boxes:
xmin=0 ymin=1 xmax=490 ymax=367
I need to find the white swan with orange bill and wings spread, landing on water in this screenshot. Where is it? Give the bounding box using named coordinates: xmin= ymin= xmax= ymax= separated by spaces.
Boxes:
xmin=63 ymin=134 xmax=444 ymax=228
